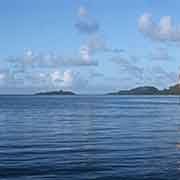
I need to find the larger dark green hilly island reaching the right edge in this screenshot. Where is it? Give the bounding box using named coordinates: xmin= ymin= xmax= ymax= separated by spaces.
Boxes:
xmin=107 ymin=84 xmax=180 ymax=95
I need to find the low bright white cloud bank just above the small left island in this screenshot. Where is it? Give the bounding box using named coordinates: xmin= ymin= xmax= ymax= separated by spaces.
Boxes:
xmin=0 ymin=69 xmax=87 ymax=90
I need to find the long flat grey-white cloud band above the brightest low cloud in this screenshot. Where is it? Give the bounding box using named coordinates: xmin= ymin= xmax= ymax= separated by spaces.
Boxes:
xmin=4 ymin=50 xmax=97 ymax=72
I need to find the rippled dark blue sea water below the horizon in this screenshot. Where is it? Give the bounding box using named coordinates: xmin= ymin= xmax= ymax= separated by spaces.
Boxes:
xmin=0 ymin=96 xmax=180 ymax=180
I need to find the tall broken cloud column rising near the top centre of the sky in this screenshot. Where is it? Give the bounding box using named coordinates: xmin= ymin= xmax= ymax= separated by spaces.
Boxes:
xmin=75 ymin=6 xmax=123 ymax=65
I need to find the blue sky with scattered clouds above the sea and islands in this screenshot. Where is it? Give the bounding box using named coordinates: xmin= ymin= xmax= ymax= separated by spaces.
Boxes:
xmin=0 ymin=0 xmax=180 ymax=94
